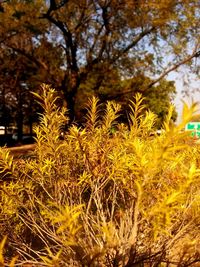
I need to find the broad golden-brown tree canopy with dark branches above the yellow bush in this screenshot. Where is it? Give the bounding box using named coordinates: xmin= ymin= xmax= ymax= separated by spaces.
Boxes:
xmin=0 ymin=0 xmax=200 ymax=131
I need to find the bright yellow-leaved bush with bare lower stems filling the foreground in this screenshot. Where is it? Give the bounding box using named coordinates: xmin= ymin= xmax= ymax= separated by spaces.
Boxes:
xmin=0 ymin=85 xmax=200 ymax=267
